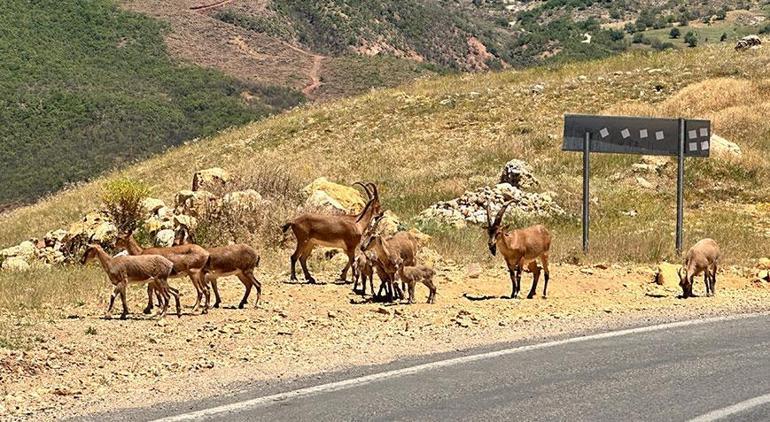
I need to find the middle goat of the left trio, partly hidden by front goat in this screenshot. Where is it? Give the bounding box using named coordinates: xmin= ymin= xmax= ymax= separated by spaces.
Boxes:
xmin=115 ymin=232 xmax=210 ymax=314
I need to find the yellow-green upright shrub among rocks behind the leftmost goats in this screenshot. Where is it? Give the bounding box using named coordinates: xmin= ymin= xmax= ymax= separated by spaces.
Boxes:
xmin=102 ymin=178 xmax=150 ymax=232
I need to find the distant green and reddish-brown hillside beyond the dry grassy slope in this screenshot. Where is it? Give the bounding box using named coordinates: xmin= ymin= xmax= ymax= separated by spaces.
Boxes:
xmin=0 ymin=0 xmax=767 ymax=209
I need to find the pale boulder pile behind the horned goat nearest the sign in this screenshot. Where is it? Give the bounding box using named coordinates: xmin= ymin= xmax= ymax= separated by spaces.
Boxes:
xmin=419 ymin=160 xmax=565 ymax=228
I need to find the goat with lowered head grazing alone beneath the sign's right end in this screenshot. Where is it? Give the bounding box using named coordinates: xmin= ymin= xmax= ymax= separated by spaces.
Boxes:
xmin=677 ymin=239 xmax=721 ymax=299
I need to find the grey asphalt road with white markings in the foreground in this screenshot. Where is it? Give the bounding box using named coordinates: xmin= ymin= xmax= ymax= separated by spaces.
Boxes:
xmin=87 ymin=315 xmax=770 ymax=421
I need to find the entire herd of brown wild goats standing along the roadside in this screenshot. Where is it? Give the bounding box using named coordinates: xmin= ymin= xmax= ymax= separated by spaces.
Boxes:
xmin=82 ymin=182 xmax=720 ymax=319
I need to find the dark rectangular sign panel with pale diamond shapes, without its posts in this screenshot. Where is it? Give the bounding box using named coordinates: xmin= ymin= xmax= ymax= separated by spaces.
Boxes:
xmin=562 ymin=114 xmax=711 ymax=157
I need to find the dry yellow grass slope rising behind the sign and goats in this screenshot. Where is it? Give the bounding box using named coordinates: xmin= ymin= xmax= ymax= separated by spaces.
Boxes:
xmin=0 ymin=42 xmax=770 ymax=261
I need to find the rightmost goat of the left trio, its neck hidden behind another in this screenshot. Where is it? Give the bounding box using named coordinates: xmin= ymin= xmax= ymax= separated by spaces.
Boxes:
xmin=174 ymin=226 xmax=262 ymax=309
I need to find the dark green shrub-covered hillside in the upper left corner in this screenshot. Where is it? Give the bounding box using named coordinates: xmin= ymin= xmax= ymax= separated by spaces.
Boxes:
xmin=0 ymin=0 xmax=302 ymax=206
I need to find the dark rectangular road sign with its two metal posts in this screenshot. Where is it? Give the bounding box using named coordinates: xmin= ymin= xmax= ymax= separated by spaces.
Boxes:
xmin=562 ymin=114 xmax=711 ymax=253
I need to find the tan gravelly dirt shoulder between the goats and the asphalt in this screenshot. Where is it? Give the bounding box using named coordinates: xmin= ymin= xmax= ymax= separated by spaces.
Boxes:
xmin=0 ymin=265 xmax=770 ymax=420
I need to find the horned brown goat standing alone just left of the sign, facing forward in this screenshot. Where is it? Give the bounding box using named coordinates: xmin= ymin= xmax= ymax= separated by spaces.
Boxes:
xmin=487 ymin=201 xmax=551 ymax=299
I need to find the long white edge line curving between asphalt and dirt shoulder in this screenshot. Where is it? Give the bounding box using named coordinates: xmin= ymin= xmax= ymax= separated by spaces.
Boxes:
xmin=155 ymin=312 xmax=770 ymax=422
